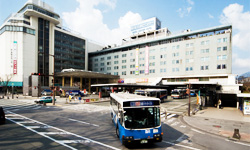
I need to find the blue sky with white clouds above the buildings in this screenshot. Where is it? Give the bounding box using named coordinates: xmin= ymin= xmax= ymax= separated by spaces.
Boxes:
xmin=0 ymin=0 xmax=250 ymax=75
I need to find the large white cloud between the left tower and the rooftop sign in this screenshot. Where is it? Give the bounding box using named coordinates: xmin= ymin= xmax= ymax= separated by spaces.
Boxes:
xmin=62 ymin=0 xmax=142 ymax=45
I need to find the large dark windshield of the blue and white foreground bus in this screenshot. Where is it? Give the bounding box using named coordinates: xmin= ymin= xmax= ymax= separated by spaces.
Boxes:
xmin=124 ymin=107 xmax=160 ymax=129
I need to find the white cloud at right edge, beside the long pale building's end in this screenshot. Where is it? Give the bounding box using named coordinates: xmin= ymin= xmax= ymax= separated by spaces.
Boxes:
xmin=220 ymin=3 xmax=250 ymax=51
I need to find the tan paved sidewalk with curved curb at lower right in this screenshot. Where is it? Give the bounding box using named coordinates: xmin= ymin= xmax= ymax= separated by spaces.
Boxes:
xmin=183 ymin=107 xmax=250 ymax=142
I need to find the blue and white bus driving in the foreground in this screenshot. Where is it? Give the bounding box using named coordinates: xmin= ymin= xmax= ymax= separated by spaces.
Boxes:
xmin=110 ymin=93 xmax=163 ymax=145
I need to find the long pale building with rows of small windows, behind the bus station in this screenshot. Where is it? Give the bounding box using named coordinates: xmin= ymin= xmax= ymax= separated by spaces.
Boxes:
xmin=89 ymin=25 xmax=232 ymax=83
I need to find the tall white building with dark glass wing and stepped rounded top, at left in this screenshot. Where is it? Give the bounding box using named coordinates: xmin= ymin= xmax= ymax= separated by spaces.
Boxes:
xmin=0 ymin=0 xmax=101 ymax=94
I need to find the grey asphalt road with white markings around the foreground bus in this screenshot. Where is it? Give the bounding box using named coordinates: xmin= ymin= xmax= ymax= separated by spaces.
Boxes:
xmin=0 ymin=99 xmax=250 ymax=150
